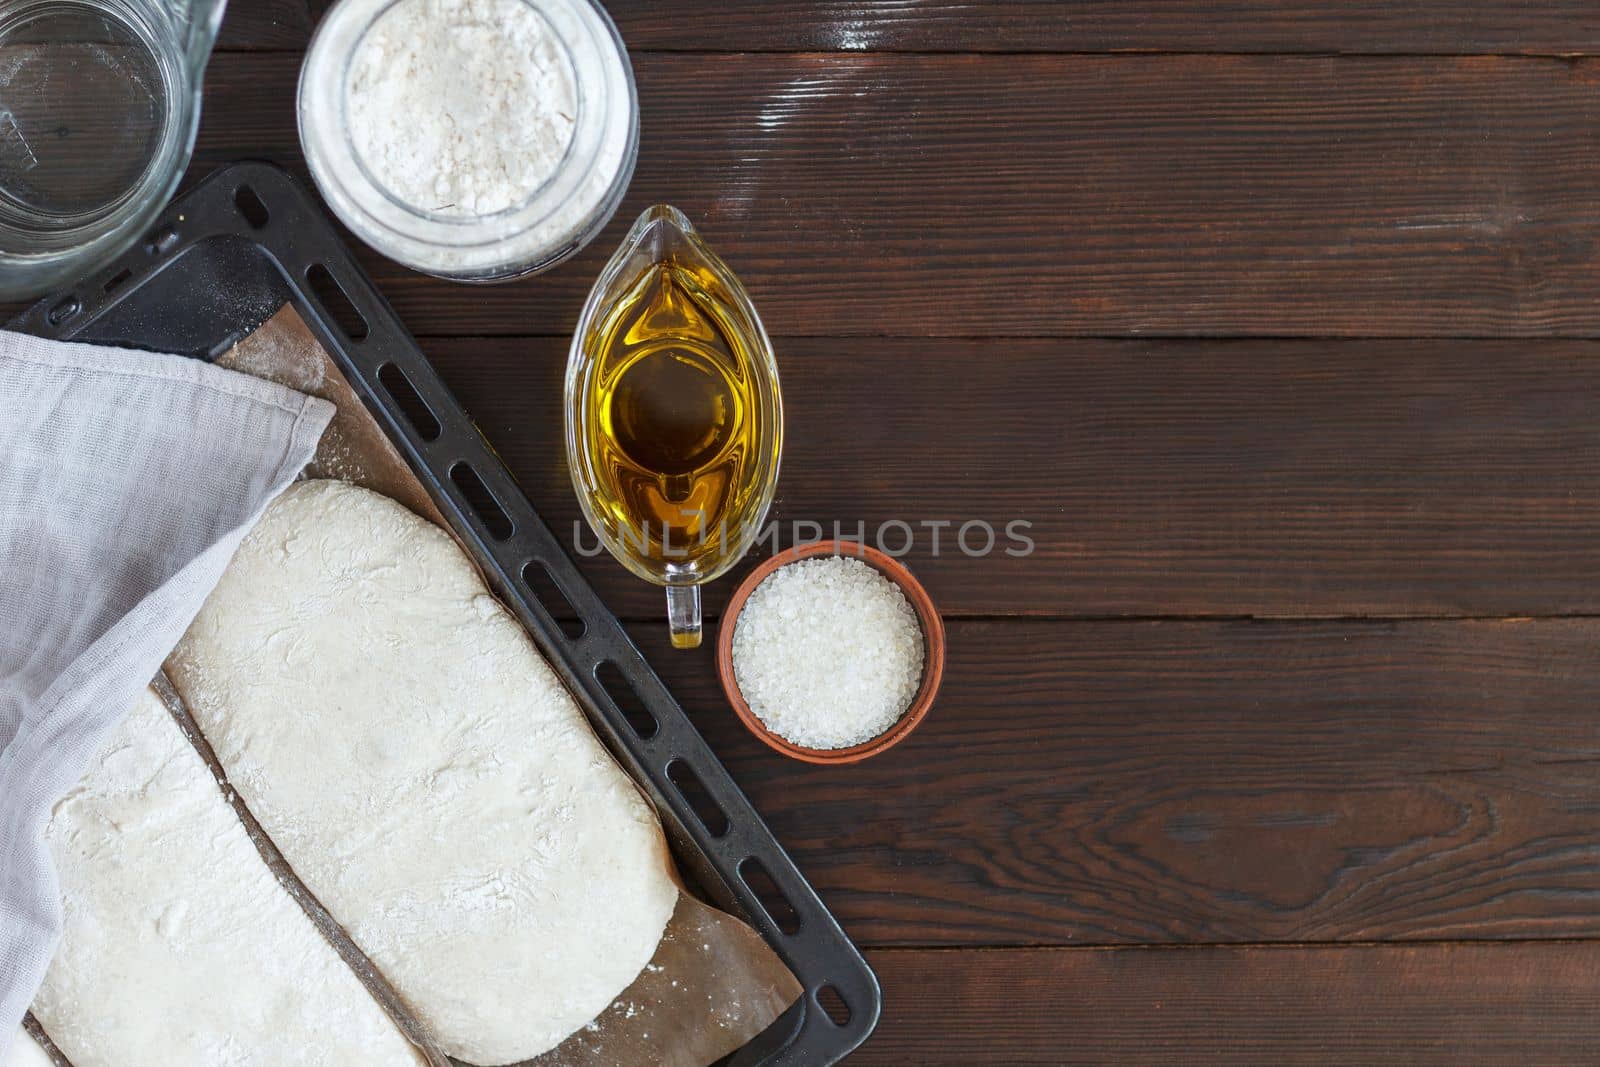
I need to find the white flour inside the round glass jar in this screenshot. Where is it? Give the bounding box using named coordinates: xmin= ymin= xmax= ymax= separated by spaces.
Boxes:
xmin=346 ymin=0 xmax=578 ymax=216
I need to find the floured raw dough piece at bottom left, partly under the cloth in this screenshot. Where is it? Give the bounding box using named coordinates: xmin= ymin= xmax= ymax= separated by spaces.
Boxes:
xmin=22 ymin=689 xmax=424 ymax=1067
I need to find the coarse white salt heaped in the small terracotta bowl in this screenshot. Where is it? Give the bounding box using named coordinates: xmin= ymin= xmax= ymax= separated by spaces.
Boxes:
xmin=733 ymin=555 xmax=925 ymax=749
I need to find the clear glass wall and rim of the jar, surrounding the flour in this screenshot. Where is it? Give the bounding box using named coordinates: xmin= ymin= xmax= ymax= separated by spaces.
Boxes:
xmin=299 ymin=0 xmax=638 ymax=282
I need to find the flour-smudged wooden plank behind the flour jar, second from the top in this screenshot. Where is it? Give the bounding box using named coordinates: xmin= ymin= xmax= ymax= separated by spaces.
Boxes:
xmin=172 ymin=54 xmax=1600 ymax=336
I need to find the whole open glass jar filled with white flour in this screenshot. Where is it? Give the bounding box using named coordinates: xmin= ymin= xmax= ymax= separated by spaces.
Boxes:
xmin=299 ymin=0 xmax=638 ymax=282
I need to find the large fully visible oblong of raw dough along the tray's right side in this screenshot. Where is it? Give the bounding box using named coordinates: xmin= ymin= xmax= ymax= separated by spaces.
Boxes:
xmin=168 ymin=482 xmax=677 ymax=1065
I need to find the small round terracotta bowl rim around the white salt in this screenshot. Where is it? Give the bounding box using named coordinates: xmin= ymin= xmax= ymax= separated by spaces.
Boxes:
xmin=717 ymin=541 xmax=944 ymax=763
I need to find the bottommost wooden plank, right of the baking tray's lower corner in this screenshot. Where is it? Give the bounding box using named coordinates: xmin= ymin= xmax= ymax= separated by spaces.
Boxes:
xmin=850 ymin=944 xmax=1600 ymax=1067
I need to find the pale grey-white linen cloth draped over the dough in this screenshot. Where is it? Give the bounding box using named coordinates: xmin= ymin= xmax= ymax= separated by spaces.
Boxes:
xmin=0 ymin=331 xmax=333 ymax=1062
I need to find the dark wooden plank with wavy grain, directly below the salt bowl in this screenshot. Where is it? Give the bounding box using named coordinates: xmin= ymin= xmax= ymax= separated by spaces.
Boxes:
xmin=630 ymin=619 xmax=1600 ymax=945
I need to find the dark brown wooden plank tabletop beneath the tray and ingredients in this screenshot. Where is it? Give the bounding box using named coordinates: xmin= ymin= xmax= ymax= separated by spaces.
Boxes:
xmin=43 ymin=0 xmax=1600 ymax=1067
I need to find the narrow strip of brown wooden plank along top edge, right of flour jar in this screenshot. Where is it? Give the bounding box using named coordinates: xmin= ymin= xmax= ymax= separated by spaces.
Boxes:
xmin=606 ymin=0 xmax=1600 ymax=54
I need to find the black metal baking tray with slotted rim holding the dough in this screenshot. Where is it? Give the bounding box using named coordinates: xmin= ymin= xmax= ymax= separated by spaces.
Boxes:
xmin=11 ymin=162 xmax=882 ymax=1067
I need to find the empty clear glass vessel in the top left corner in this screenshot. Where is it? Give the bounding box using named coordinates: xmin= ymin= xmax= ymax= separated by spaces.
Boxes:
xmin=0 ymin=0 xmax=224 ymax=299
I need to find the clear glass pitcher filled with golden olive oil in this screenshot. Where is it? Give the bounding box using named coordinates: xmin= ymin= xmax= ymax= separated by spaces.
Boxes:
xmin=566 ymin=205 xmax=784 ymax=648
